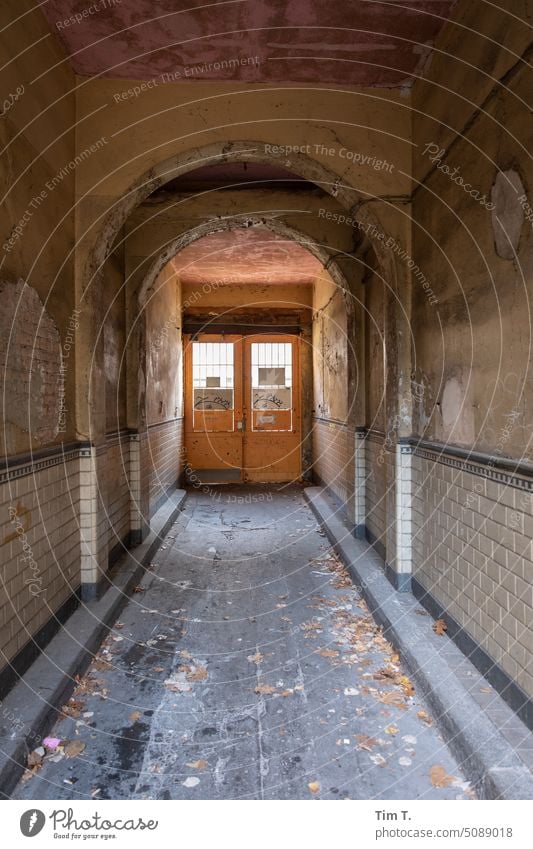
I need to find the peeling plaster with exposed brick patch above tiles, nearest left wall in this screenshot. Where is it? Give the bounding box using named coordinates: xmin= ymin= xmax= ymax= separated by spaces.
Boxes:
xmin=0 ymin=0 xmax=75 ymax=454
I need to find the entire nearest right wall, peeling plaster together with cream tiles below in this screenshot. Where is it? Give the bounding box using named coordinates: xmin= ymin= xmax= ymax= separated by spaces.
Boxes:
xmin=411 ymin=0 xmax=533 ymax=697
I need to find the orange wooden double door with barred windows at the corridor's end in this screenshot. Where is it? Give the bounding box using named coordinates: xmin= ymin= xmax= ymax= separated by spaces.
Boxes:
xmin=184 ymin=333 xmax=301 ymax=483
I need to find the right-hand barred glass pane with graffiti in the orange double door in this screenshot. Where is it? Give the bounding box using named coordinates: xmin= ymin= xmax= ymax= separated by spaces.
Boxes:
xmin=251 ymin=342 xmax=292 ymax=431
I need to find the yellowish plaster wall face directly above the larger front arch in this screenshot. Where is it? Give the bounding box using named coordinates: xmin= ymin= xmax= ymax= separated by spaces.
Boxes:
xmin=78 ymin=78 xmax=411 ymax=208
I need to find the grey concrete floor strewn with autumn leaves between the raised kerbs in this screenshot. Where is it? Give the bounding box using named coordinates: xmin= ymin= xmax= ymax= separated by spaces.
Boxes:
xmin=14 ymin=486 xmax=473 ymax=799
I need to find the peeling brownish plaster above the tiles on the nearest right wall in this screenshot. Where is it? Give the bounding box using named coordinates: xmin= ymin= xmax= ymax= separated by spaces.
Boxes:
xmin=413 ymin=3 xmax=533 ymax=459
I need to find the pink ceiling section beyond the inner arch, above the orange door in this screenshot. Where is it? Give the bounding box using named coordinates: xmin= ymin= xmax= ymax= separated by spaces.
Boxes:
xmin=168 ymin=227 xmax=322 ymax=286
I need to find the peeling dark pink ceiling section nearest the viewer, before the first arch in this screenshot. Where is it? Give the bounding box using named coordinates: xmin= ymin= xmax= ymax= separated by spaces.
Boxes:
xmin=41 ymin=0 xmax=454 ymax=86
